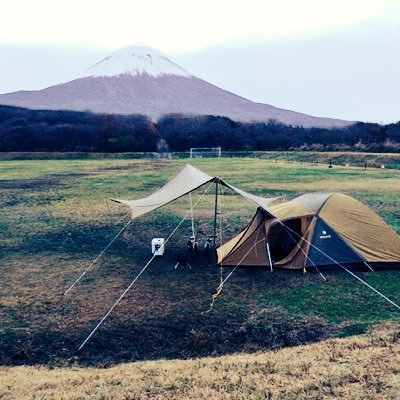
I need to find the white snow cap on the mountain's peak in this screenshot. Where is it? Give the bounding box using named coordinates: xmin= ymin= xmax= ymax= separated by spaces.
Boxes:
xmin=77 ymin=46 xmax=192 ymax=78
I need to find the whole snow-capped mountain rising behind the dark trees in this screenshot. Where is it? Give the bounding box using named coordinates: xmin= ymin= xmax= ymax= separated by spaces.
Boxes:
xmin=0 ymin=46 xmax=352 ymax=128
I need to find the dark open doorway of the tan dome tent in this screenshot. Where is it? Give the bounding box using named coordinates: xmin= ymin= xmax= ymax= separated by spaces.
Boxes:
xmin=268 ymin=218 xmax=302 ymax=262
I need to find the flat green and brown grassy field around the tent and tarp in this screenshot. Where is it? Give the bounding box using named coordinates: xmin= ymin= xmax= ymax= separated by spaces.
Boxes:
xmin=0 ymin=158 xmax=400 ymax=370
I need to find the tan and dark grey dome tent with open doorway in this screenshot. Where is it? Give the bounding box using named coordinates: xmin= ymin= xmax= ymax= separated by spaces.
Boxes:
xmin=217 ymin=192 xmax=400 ymax=269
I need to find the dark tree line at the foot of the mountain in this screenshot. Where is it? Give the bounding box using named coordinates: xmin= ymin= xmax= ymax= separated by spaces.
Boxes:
xmin=0 ymin=106 xmax=400 ymax=152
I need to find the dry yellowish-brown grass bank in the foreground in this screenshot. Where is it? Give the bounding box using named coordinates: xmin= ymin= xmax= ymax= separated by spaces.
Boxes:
xmin=0 ymin=325 xmax=400 ymax=400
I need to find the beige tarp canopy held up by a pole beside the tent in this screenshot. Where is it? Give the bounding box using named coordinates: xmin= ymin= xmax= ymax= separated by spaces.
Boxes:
xmin=111 ymin=164 xmax=278 ymax=218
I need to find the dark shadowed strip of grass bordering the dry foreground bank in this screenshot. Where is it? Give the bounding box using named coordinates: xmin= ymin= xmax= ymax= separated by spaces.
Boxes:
xmin=0 ymin=310 xmax=330 ymax=366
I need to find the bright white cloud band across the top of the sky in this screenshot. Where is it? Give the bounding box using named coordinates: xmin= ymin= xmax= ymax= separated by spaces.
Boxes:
xmin=0 ymin=0 xmax=400 ymax=52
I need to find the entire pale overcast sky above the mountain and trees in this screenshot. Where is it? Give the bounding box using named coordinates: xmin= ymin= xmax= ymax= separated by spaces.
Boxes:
xmin=0 ymin=0 xmax=400 ymax=122
